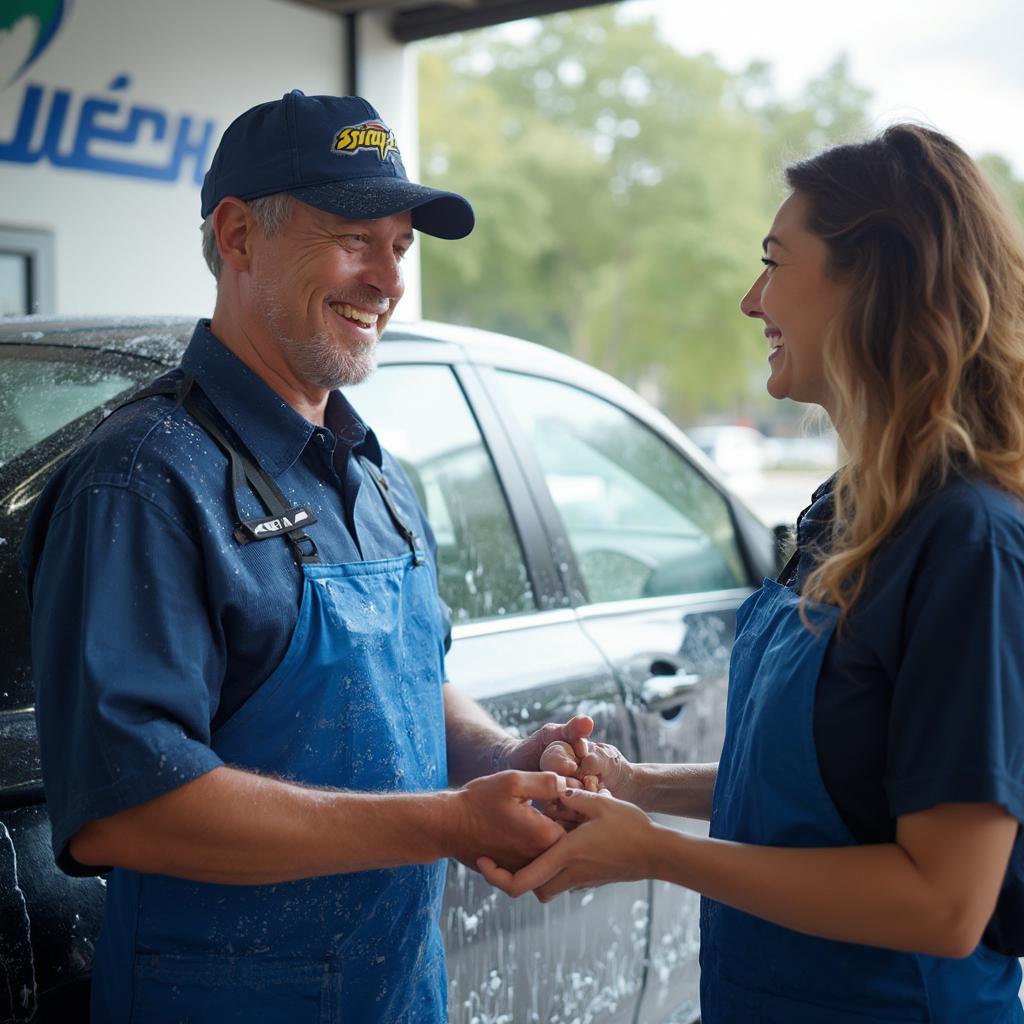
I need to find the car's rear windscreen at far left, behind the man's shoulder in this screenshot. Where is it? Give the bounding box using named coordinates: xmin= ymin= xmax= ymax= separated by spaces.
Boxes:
xmin=0 ymin=346 xmax=142 ymax=465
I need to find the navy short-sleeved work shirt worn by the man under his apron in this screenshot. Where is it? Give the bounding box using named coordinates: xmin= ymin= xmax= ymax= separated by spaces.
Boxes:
xmin=22 ymin=321 xmax=450 ymax=873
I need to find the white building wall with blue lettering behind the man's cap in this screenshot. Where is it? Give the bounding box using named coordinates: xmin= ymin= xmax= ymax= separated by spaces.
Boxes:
xmin=0 ymin=0 xmax=419 ymax=314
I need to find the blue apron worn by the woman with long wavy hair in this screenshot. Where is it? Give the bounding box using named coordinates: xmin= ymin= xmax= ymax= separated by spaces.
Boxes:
xmin=700 ymin=580 xmax=1024 ymax=1024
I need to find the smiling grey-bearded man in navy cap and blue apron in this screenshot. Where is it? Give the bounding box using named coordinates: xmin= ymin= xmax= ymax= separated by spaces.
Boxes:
xmin=23 ymin=91 xmax=592 ymax=1024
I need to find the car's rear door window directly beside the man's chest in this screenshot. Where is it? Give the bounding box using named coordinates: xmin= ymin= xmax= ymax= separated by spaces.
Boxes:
xmin=349 ymin=366 xmax=537 ymax=623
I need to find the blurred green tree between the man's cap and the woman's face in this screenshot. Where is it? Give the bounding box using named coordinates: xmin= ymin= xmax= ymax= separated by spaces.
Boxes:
xmin=420 ymin=6 xmax=868 ymax=420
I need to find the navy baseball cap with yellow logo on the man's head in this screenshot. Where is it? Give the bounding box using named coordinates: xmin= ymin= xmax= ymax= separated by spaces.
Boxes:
xmin=202 ymin=89 xmax=473 ymax=239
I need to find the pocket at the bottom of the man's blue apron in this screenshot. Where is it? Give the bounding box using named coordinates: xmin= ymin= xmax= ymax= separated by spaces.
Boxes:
xmin=131 ymin=954 xmax=341 ymax=1024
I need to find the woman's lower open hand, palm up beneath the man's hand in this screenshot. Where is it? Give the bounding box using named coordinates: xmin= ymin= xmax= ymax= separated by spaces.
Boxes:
xmin=476 ymin=790 xmax=658 ymax=903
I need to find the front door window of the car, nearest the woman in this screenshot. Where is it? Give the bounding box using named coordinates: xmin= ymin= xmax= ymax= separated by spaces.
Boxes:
xmin=498 ymin=372 xmax=744 ymax=602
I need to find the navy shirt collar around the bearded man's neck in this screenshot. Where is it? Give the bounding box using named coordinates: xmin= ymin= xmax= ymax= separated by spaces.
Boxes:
xmin=181 ymin=319 xmax=381 ymax=476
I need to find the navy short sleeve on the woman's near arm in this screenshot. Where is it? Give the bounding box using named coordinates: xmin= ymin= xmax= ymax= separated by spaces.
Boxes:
xmin=886 ymin=541 xmax=1024 ymax=821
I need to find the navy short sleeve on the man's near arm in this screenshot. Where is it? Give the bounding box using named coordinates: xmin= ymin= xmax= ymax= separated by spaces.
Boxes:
xmin=30 ymin=484 xmax=223 ymax=874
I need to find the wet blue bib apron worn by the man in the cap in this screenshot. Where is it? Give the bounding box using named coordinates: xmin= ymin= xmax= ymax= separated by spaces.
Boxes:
xmin=83 ymin=386 xmax=447 ymax=1024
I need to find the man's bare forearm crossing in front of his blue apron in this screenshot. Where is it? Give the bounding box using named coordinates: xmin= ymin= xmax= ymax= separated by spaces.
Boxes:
xmin=71 ymin=767 xmax=456 ymax=885
